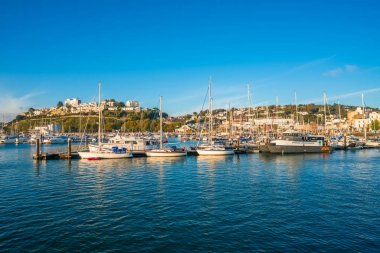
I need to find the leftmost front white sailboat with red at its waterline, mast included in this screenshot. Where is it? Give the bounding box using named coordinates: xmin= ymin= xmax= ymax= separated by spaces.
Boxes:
xmin=78 ymin=83 xmax=133 ymax=160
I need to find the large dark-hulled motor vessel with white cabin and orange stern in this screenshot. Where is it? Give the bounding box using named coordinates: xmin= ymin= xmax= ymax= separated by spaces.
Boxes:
xmin=268 ymin=130 xmax=332 ymax=154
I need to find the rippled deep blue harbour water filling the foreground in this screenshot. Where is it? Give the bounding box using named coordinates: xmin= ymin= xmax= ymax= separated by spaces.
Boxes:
xmin=0 ymin=145 xmax=380 ymax=252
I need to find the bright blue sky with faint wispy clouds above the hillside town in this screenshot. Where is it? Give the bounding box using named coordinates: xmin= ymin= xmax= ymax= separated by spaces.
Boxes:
xmin=0 ymin=0 xmax=380 ymax=119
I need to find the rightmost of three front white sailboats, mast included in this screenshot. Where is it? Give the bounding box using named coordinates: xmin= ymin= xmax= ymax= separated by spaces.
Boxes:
xmin=196 ymin=80 xmax=234 ymax=156
